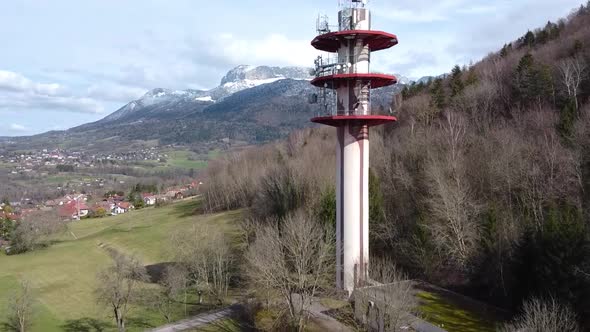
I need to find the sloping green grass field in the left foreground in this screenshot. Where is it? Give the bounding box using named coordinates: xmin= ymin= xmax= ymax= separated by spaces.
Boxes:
xmin=0 ymin=200 xmax=241 ymax=331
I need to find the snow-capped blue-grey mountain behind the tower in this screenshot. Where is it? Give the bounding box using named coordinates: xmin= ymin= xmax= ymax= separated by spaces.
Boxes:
xmin=63 ymin=66 xmax=409 ymax=149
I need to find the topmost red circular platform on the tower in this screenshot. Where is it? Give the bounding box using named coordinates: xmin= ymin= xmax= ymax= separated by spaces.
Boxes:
xmin=311 ymin=30 xmax=398 ymax=53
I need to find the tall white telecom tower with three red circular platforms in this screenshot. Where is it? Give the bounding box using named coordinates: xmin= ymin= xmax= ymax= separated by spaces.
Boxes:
xmin=310 ymin=0 xmax=398 ymax=293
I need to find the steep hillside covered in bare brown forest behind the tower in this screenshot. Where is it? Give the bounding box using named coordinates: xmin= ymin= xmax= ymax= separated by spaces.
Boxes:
xmin=206 ymin=3 xmax=590 ymax=327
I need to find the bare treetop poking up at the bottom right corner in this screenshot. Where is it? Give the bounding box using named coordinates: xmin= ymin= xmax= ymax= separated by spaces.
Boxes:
xmin=502 ymin=298 xmax=580 ymax=332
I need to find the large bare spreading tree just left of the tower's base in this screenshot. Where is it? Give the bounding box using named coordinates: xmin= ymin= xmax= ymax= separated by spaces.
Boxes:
xmin=246 ymin=212 xmax=333 ymax=331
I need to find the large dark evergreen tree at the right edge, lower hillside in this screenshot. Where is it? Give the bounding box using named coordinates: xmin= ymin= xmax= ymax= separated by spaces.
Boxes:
xmin=514 ymin=203 xmax=590 ymax=312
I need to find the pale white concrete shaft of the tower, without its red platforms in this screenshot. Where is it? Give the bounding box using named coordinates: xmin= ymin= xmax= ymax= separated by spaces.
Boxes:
xmin=336 ymin=8 xmax=371 ymax=293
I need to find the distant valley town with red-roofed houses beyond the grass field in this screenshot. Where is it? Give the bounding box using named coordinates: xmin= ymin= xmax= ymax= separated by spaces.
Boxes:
xmin=0 ymin=146 xmax=206 ymax=220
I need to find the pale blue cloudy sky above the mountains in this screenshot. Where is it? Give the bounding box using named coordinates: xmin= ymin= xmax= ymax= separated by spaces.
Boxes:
xmin=0 ymin=0 xmax=585 ymax=136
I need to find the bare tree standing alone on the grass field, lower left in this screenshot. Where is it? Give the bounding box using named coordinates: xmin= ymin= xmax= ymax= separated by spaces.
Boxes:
xmin=95 ymin=250 xmax=148 ymax=332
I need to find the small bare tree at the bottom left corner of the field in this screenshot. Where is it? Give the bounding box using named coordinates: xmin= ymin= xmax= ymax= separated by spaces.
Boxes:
xmin=4 ymin=280 xmax=33 ymax=332
